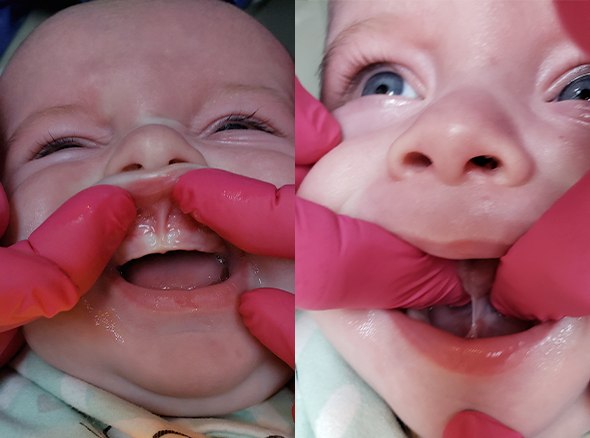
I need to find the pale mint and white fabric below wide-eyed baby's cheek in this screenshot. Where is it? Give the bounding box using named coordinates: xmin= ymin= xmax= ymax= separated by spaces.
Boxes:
xmin=295 ymin=312 xmax=406 ymax=438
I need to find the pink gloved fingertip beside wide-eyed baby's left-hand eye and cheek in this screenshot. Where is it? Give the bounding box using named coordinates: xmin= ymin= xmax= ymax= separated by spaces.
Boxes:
xmin=295 ymin=78 xmax=342 ymax=166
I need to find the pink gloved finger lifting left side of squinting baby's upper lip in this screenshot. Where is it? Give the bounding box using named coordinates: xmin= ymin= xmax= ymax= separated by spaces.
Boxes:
xmin=15 ymin=185 xmax=137 ymax=291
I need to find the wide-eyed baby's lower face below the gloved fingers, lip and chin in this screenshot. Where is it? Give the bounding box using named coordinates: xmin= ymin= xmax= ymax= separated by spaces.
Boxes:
xmin=314 ymin=310 xmax=590 ymax=438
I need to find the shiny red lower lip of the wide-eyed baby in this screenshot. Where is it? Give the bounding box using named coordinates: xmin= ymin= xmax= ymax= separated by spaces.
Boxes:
xmin=390 ymin=311 xmax=581 ymax=376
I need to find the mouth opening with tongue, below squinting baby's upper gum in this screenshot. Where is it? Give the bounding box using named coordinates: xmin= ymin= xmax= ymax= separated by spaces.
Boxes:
xmin=121 ymin=251 xmax=229 ymax=291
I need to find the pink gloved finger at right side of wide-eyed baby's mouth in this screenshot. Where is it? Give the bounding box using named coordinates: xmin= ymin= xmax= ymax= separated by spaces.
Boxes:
xmin=491 ymin=174 xmax=590 ymax=321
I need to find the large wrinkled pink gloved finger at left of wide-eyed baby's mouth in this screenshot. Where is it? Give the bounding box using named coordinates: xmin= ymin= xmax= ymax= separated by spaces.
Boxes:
xmin=295 ymin=198 xmax=468 ymax=310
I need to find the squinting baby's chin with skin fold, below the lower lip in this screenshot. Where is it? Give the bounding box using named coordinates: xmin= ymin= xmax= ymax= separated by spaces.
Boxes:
xmin=25 ymin=292 xmax=292 ymax=417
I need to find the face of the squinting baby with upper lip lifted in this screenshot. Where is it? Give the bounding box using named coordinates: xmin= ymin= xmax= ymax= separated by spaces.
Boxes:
xmin=0 ymin=0 xmax=294 ymax=416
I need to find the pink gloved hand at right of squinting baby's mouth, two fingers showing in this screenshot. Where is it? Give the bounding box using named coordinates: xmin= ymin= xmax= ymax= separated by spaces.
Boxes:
xmin=172 ymin=169 xmax=295 ymax=368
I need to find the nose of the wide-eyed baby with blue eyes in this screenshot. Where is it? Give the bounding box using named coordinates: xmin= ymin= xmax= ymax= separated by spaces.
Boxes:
xmin=387 ymin=90 xmax=534 ymax=186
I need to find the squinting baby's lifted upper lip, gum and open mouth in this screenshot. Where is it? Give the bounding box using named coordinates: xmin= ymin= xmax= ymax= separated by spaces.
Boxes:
xmin=102 ymin=165 xmax=239 ymax=292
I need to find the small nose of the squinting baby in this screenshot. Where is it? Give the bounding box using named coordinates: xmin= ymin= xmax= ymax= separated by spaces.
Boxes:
xmin=105 ymin=124 xmax=207 ymax=175
